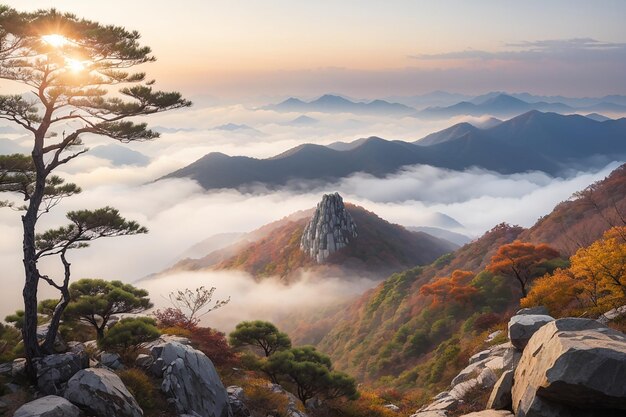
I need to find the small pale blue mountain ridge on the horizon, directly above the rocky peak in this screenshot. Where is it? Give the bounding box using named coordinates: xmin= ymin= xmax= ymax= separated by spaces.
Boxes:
xmin=264 ymin=94 xmax=415 ymax=115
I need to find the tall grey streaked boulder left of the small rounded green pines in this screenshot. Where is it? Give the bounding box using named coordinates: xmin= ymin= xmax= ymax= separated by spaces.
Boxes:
xmin=159 ymin=342 xmax=232 ymax=417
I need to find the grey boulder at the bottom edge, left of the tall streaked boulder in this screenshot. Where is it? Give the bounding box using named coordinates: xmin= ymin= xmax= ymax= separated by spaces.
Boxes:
xmin=65 ymin=368 xmax=143 ymax=417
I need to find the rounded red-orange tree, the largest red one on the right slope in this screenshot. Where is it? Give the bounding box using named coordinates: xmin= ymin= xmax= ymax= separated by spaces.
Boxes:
xmin=486 ymin=240 xmax=560 ymax=297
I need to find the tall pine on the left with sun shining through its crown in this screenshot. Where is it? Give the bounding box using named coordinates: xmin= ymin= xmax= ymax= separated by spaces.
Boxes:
xmin=0 ymin=6 xmax=191 ymax=370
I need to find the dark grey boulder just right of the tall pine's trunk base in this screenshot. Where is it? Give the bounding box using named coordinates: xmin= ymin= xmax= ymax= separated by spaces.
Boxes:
xmin=35 ymin=352 xmax=85 ymax=395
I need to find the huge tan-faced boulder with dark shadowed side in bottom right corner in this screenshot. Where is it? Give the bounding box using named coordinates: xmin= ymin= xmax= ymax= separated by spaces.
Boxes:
xmin=511 ymin=318 xmax=626 ymax=417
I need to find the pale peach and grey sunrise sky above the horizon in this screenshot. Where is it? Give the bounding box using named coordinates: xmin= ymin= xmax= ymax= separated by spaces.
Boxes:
xmin=0 ymin=0 xmax=626 ymax=98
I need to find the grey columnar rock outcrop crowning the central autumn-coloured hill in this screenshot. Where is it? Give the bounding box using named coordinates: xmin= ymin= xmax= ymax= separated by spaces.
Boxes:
xmin=300 ymin=193 xmax=357 ymax=263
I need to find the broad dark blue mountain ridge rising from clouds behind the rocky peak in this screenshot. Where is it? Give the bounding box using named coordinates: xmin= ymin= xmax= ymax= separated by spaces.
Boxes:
xmin=165 ymin=111 xmax=626 ymax=189
